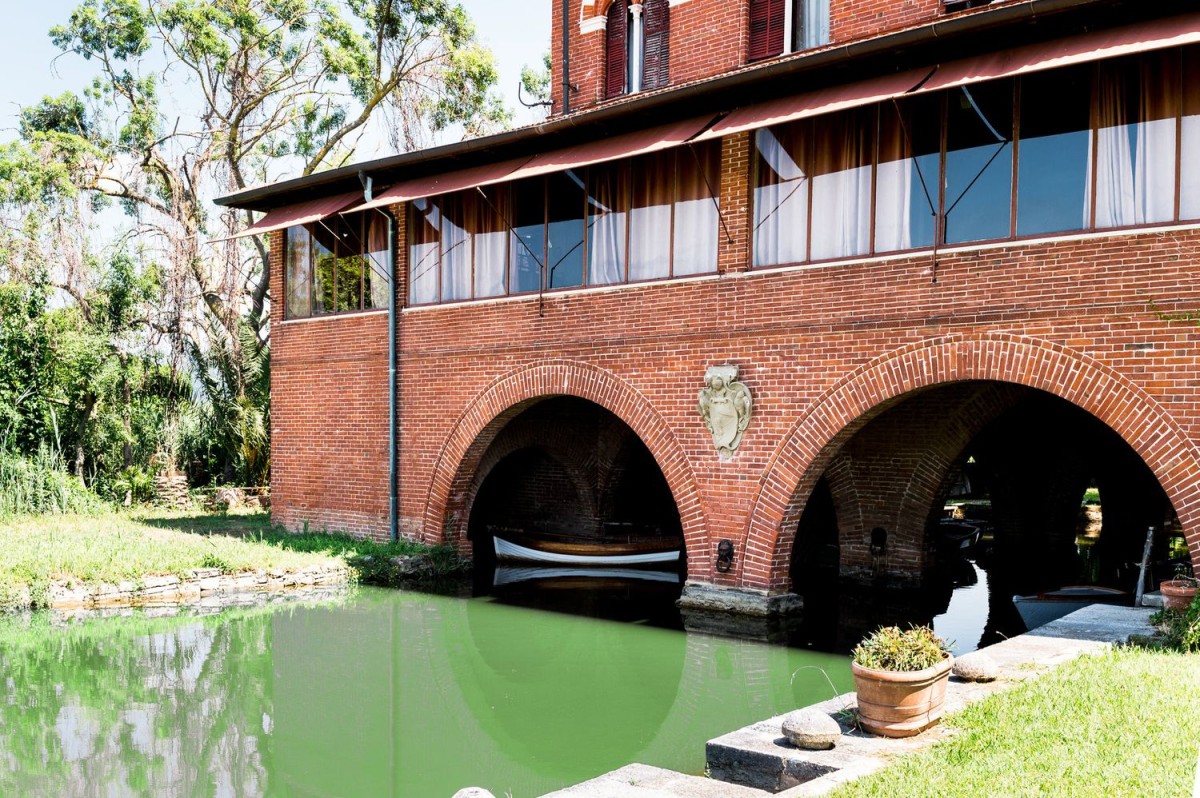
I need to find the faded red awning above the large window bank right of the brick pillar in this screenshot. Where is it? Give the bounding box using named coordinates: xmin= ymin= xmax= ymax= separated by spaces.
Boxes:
xmin=696 ymin=13 xmax=1200 ymax=139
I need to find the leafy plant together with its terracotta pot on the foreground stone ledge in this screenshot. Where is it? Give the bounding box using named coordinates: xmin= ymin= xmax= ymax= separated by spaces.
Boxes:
xmin=851 ymin=626 xmax=954 ymax=737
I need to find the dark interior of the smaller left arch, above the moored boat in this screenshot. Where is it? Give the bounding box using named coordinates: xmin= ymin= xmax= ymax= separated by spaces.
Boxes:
xmin=468 ymin=396 xmax=683 ymax=558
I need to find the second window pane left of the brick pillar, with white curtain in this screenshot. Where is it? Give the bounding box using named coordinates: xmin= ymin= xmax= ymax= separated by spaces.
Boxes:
xmin=629 ymin=150 xmax=676 ymax=280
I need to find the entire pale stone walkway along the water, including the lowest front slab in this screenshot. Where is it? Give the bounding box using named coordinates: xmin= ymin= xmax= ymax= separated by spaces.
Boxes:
xmin=544 ymin=605 xmax=1153 ymax=798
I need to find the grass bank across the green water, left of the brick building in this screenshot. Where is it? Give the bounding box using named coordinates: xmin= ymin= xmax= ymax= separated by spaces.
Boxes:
xmin=0 ymin=510 xmax=446 ymax=608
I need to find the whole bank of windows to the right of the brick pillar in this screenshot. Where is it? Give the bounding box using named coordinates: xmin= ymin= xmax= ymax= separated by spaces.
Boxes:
xmin=751 ymin=47 xmax=1200 ymax=266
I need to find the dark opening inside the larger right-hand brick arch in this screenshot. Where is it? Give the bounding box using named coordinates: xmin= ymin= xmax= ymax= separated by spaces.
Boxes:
xmin=790 ymin=380 xmax=1182 ymax=649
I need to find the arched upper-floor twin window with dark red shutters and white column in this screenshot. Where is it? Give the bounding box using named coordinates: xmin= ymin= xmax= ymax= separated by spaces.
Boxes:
xmin=605 ymin=0 xmax=671 ymax=97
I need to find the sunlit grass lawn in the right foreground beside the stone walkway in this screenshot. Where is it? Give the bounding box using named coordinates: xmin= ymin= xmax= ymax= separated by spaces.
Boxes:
xmin=830 ymin=648 xmax=1200 ymax=798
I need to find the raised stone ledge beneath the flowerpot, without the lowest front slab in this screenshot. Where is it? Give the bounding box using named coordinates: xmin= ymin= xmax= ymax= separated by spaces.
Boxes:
xmin=706 ymin=605 xmax=1153 ymax=798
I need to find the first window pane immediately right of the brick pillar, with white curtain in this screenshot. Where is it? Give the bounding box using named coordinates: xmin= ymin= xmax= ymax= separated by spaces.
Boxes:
xmin=752 ymin=124 xmax=811 ymax=266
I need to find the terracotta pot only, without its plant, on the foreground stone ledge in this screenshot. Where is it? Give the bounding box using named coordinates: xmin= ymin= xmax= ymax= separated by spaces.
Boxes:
xmin=851 ymin=655 xmax=954 ymax=737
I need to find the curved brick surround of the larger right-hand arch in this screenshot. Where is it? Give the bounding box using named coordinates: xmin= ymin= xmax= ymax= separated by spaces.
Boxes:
xmin=743 ymin=334 xmax=1200 ymax=590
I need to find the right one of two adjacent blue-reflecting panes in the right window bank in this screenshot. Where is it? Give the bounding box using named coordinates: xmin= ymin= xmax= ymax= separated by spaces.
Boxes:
xmin=1016 ymin=66 xmax=1092 ymax=235
